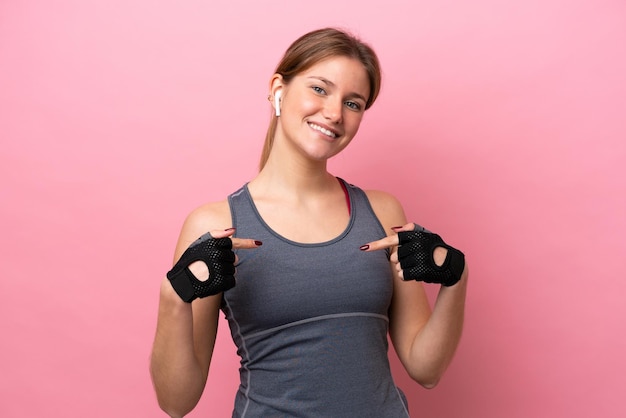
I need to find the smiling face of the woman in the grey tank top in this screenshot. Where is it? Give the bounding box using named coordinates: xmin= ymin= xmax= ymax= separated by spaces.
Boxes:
xmin=276 ymin=57 xmax=370 ymax=160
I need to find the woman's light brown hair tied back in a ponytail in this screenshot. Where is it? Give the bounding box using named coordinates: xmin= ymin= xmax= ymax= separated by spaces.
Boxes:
xmin=259 ymin=28 xmax=381 ymax=169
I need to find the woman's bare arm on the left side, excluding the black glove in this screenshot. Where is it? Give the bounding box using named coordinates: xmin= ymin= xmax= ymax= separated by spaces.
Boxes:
xmin=150 ymin=202 xmax=231 ymax=417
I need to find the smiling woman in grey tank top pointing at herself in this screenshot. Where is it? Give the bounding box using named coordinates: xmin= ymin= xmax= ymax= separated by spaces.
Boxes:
xmin=151 ymin=28 xmax=467 ymax=418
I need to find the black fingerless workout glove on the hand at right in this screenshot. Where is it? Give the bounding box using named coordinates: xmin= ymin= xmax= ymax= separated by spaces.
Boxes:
xmin=398 ymin=225 xmax=465 ymax=286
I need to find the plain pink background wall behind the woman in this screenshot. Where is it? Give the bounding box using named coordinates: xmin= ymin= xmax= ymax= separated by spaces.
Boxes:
xmin=0 ymin=0 xmax=626 ymax=418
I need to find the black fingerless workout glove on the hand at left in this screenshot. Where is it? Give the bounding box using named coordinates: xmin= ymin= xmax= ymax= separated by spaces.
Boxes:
xmin=167 ymin=232 xmax=235 ymax=302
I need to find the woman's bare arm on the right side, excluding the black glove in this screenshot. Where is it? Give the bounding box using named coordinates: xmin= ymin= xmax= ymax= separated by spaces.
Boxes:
xmin=368 ymin=192 xmax=468 ymax=388
